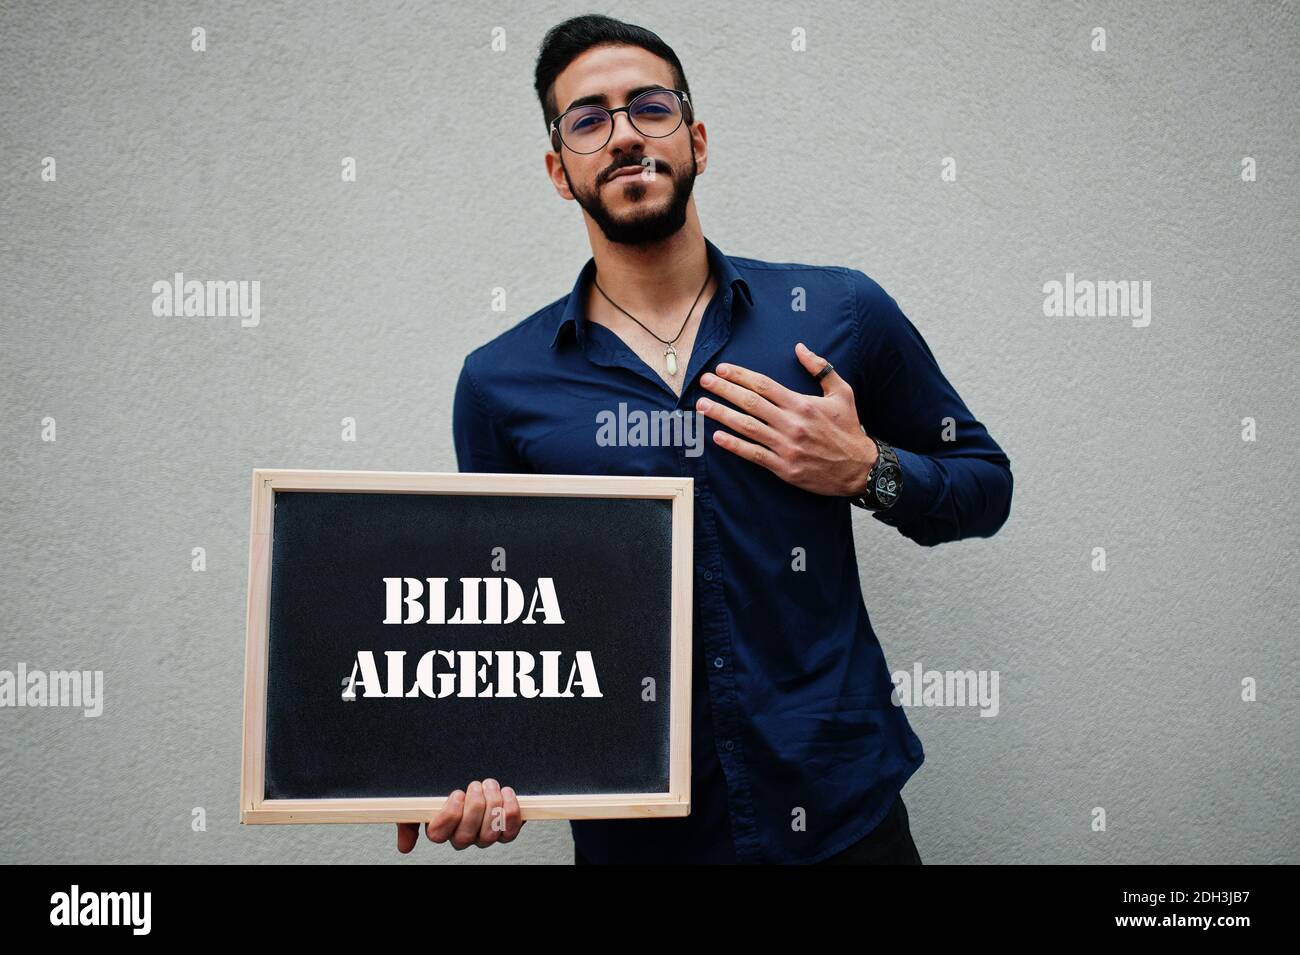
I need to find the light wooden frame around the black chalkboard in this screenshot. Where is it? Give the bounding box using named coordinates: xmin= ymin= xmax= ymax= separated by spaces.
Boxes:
xmin=239 ymin=468 xmax=694 ymax=824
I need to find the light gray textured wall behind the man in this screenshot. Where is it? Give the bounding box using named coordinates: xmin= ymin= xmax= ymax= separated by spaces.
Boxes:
xmin=0 ymin=1 xmax=1300 ymax=863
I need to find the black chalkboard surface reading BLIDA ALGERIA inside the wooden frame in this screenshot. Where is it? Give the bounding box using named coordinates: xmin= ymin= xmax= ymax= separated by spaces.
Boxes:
xmin=246 ymin=476 xmax=689 ymax=821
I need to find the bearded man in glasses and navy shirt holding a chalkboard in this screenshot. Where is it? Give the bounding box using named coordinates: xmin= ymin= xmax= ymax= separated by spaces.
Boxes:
xmin=398 ymin=16 xmax=1011 ymax=863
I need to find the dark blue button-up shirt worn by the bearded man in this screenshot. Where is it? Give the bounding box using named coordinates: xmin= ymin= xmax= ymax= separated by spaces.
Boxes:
xmin=452 ymin=239 xmax=1011 ymax=863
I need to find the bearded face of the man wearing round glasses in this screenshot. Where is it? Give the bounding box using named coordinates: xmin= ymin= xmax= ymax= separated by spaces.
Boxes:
xmin=546 ymin=45 xmax=709 ymax=246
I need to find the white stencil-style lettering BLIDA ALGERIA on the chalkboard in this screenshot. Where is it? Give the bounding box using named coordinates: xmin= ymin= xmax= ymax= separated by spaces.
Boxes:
xmin=343 ymin=577 xmax=602 ymax=700
